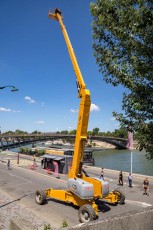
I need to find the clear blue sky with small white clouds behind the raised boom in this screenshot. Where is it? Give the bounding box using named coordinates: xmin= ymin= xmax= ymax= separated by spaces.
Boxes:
xmin=0 ymin=0 xmax=123 ymax=133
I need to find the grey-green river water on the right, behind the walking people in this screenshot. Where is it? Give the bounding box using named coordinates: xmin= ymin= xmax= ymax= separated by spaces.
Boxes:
xmin=93 ymin=149 xmax=153 ymax=176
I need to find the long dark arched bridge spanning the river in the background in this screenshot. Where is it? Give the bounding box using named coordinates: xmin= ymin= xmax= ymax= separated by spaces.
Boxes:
xmin=0 ymin=133 xmax=127 ymax=150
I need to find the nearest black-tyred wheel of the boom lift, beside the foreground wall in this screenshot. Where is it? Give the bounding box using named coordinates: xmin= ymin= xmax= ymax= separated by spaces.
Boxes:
xmin=78 ymin=204 xmax=96 ymax=223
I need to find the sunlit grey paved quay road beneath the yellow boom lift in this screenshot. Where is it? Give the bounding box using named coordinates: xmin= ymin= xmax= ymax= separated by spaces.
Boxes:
xmin=0 ymin=152 xmax=153 ymax=229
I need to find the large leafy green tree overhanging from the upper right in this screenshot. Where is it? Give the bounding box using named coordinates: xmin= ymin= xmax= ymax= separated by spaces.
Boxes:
xmin=91 ymin=0 xmax=153 ymax=159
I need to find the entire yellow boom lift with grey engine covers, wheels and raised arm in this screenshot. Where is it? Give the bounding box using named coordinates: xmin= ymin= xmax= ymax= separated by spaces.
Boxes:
xmin=35 ymin=9 xmax=125 ymax=222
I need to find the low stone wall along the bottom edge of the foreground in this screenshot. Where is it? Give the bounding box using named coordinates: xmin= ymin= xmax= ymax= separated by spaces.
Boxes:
xmin=10 ymin=207 xmax=153 ymax=230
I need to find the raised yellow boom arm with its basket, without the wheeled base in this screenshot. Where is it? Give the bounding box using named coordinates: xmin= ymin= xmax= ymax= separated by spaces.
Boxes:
xmin=48 ymin=9 xmax=91 ymax=178
